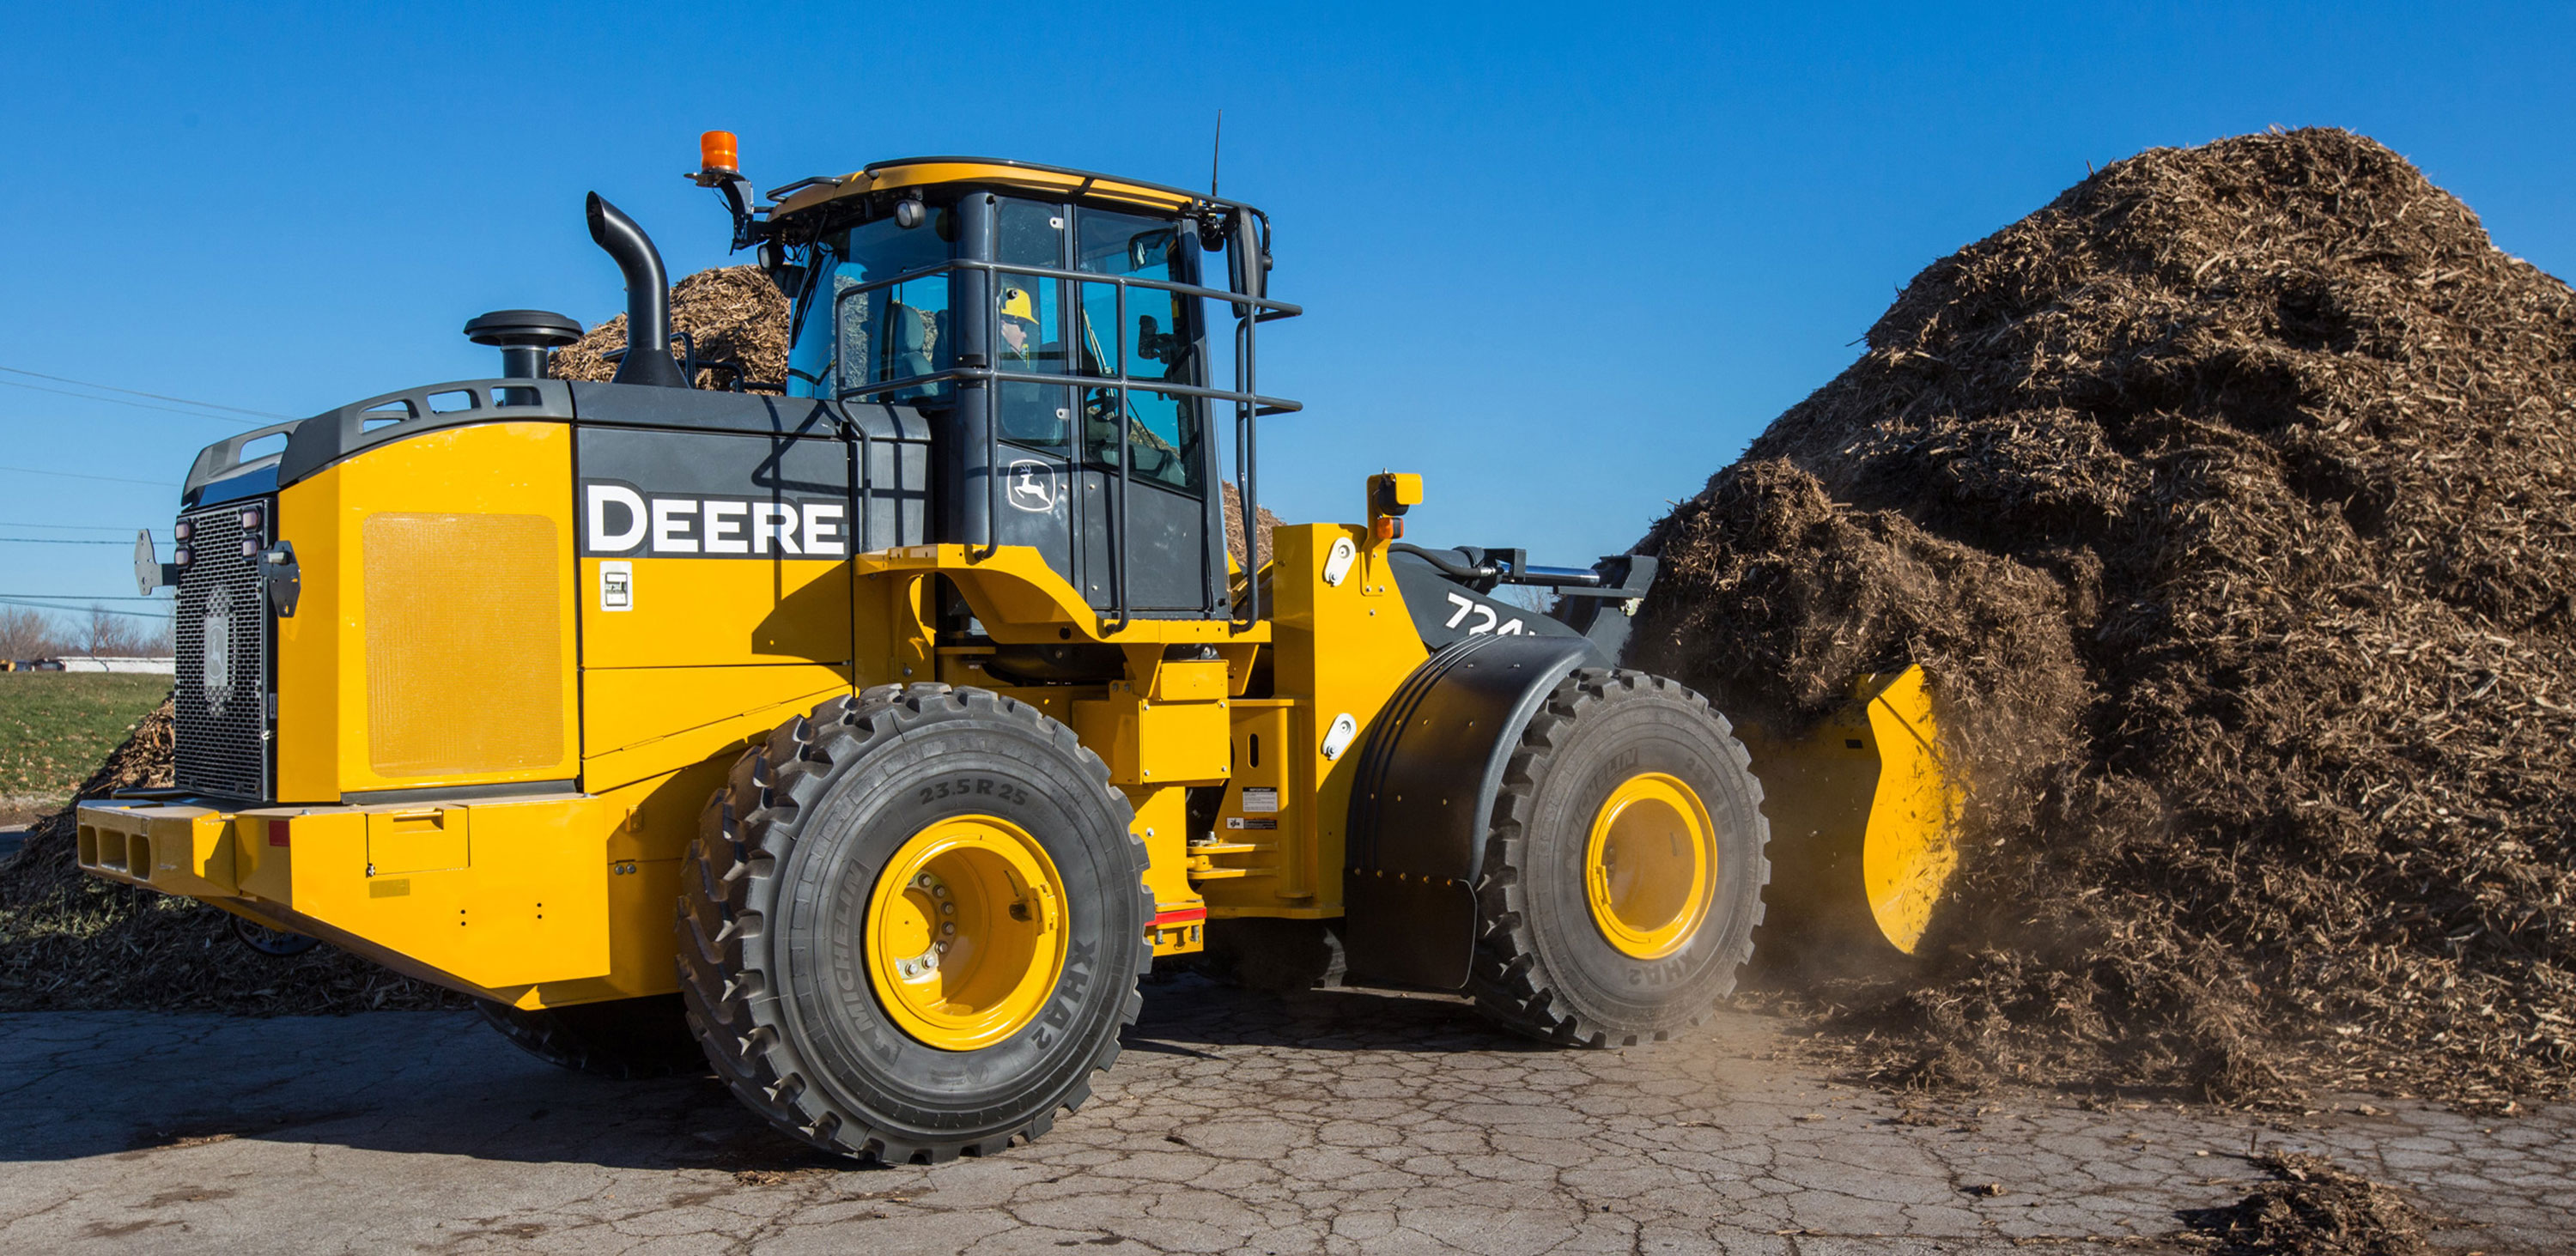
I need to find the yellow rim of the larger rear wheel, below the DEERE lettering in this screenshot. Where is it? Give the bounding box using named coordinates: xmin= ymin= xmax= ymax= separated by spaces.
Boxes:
xmin=866 ymin=816 xmax=1064 ymax=1050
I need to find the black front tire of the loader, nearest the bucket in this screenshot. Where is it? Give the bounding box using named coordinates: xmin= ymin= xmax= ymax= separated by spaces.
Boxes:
xmin=1468 ymin=669 xmax=1770 ymax=1047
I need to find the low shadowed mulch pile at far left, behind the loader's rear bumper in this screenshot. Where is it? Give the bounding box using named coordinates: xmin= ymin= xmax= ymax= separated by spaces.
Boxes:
xmin=0 ymin=702 xmax=469 ymax=1016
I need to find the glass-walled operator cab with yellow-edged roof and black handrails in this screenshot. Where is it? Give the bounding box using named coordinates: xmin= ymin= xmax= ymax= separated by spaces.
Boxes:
xmin=762 ymin=157 xmax=1296 ymax=623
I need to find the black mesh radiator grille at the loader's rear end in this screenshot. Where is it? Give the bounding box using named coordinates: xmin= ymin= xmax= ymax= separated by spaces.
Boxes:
xmin=173 ymin=500 xmax=276 ymax=798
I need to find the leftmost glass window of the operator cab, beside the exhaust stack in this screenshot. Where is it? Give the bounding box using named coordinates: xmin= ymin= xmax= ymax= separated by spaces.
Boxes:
xmin=788 ymin=209 xmax=956 ymax=402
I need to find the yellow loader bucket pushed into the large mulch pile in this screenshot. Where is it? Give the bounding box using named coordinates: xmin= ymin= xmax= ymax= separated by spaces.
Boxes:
xmin=1744 ymin=666 xmax=1958 ymax=960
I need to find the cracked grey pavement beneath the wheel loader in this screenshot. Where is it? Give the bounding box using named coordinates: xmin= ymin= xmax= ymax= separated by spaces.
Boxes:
xmin=0 ymin=978 xmax=2576 ymax=1256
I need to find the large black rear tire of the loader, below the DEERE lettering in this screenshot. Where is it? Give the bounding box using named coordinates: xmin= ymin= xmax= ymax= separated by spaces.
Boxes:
xmin=680 ymin=684 xmax=1154 ymax=1163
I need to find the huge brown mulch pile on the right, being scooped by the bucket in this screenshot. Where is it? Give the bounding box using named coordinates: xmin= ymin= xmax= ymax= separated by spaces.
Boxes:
xmin=1631 ymin=129 xmax=2576 ymax=1107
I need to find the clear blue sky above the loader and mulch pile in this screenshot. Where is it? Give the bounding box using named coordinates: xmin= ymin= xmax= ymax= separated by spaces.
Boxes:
xmin=0 ymin=3 xmax=2576 ymax=625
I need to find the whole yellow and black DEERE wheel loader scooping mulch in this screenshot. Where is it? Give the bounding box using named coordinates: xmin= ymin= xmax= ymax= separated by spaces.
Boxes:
xmin=77 ymin=131 xmax=1953 ymax=1161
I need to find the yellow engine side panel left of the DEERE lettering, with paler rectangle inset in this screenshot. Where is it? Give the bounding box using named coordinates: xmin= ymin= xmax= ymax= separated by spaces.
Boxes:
xmin=276 ymin=422 xmax=580 ymax=800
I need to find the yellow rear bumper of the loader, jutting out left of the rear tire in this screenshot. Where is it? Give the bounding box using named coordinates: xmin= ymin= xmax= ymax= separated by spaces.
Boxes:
xmin=77 ymin=795 xmax=618 ymax=1004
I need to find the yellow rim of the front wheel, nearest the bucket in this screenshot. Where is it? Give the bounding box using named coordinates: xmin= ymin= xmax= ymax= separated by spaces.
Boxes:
xmin=1584 ymin=772 xmax=1718 ymax=960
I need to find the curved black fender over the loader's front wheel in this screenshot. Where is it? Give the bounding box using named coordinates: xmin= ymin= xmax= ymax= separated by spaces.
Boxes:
xmin=1342 ymin=635 xmax=1600 ymax=991
